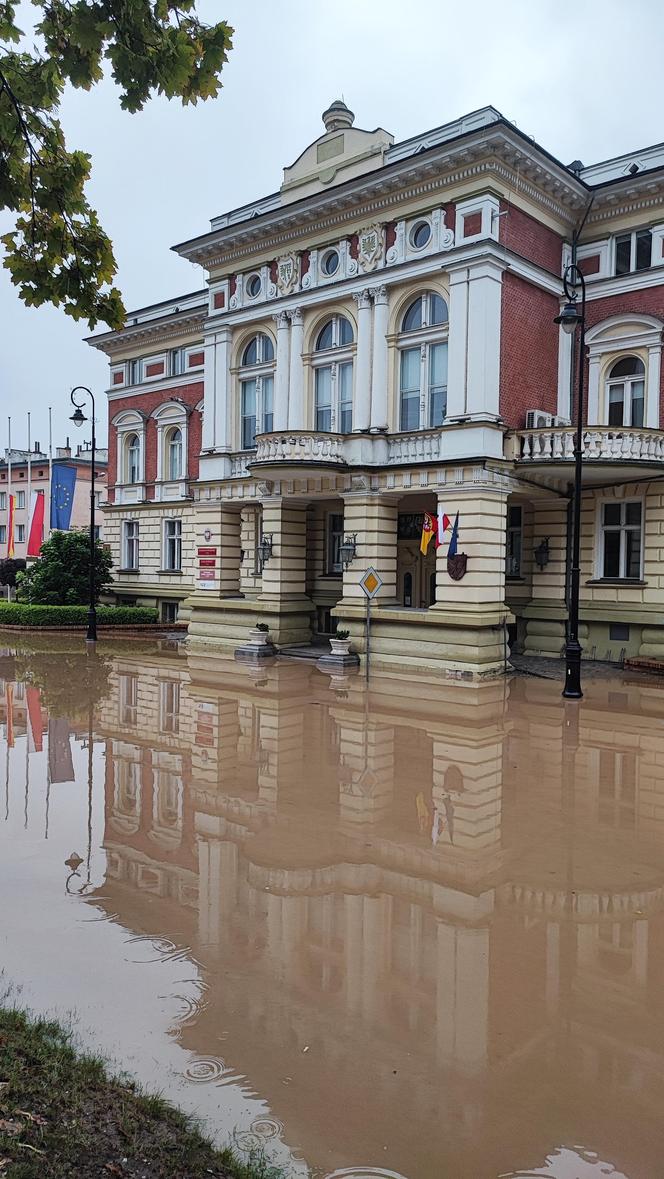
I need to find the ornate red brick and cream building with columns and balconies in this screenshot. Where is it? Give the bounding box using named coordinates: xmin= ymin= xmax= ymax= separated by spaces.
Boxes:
xmin=91 ymin=101 xmax=664 ymax=677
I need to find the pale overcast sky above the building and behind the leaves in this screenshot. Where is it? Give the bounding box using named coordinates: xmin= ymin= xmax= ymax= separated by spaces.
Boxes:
xmin=0 ymin=0 xmax=664 ymax=448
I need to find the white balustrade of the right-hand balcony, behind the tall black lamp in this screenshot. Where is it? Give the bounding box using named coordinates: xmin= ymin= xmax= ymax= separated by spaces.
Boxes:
xmin=517 ymin=426 xmax=664 ymax=462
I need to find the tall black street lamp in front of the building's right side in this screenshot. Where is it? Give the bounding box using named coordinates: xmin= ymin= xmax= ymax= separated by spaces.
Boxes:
xmin=554 ymin=262 xmax=586 ymax=700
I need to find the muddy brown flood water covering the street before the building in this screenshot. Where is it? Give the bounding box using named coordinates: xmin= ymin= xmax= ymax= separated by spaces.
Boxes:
xmin=0 ymin=634 xmax=664 ymax=1179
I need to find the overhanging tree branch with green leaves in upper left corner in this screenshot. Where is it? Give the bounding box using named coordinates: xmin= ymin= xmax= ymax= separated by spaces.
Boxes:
xmin=0 ymin=0 xmax=232 ymax=328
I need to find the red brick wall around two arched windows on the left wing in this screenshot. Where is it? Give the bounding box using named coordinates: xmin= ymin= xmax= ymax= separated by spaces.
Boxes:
xmin=109 ymin=381 xmax=203 ymax=503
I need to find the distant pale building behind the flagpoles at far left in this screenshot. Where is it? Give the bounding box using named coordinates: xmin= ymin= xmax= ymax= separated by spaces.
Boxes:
xmin=0 ymin=439 xmax=109 ymax=558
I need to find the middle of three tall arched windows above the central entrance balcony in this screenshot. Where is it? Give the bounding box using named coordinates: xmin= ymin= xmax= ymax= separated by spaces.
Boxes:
xmin=313 ymin=315 xmax=354 ymax=434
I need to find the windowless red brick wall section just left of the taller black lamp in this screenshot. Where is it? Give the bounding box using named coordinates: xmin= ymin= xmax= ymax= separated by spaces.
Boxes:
xmin=500 ymin=271 xmax=559 ymax=429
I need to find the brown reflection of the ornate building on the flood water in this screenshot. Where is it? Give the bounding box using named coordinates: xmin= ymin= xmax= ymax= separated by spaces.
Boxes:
xmin=94 ymin=656 xmax=664 ymax=1179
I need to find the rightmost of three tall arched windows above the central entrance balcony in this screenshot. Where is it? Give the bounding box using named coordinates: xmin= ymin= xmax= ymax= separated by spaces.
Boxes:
xmin=397 ymin=291 xmax=448 ymax=430
